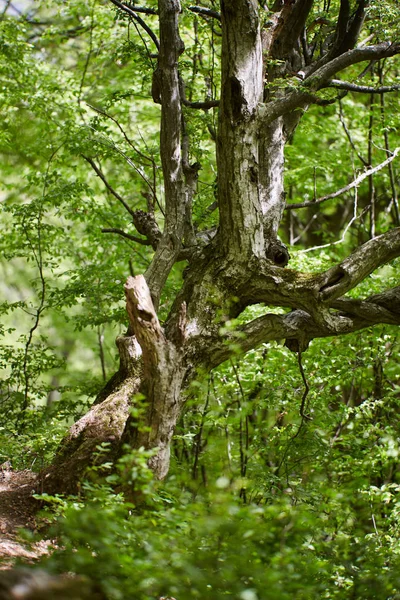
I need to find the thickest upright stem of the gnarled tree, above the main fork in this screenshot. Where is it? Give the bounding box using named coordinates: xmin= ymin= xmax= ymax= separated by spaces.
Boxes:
xmin=217 ymin=0 xmax=265 ymax=257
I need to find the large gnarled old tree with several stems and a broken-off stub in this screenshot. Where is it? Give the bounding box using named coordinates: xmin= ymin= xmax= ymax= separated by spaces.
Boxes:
xmin=0 ymin=0 xmax=400 ymax=491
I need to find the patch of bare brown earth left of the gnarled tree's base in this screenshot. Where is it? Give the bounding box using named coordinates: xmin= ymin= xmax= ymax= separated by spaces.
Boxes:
xmin=0 ymin=471 xmax=51 ymax=570
